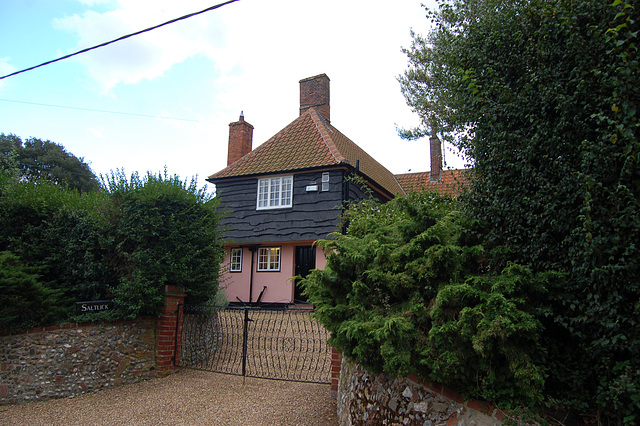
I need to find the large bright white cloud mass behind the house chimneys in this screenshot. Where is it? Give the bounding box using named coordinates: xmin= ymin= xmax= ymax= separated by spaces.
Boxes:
xmin=36 ymin=0 xmax=464 ymax=175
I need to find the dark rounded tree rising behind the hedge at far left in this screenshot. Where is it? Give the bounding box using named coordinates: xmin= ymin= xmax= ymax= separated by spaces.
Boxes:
xmin=0 ymin=133 xmax=100 ymax=192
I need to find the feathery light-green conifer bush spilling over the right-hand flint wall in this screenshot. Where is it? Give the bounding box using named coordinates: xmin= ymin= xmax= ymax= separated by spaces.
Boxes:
xmin=304 ymin=193 xmax=558 ymax=405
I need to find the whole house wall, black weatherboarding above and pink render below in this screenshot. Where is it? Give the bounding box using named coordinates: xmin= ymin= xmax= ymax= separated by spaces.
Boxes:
xmin=216 ymin=169 xmax=379 ymax=303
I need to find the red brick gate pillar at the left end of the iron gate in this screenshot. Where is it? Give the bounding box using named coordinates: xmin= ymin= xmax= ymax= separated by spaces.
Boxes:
xmin=156 ymin=285 xmax=185 ymax=376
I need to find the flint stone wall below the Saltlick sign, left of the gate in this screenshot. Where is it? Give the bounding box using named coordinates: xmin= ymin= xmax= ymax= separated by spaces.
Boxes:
xmin=0 ymin=318 xmax=156 ymax=404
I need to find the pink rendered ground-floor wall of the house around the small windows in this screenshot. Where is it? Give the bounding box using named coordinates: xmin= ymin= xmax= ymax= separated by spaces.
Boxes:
xmin=220 ymin=244 xmax=327 ymax=303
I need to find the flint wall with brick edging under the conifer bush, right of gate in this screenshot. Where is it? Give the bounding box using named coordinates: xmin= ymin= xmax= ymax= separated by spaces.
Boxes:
xmin=337 ymin=358 xmax=504 ymax=426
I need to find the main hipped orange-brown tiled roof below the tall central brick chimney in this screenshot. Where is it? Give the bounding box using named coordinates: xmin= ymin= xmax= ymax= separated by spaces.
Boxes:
xmin=208 ymin=108 xmax=403 ymax=195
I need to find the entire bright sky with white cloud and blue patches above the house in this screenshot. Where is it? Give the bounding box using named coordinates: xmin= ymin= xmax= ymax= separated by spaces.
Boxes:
xmin=0 ymin=0 xmax=464 ymax=190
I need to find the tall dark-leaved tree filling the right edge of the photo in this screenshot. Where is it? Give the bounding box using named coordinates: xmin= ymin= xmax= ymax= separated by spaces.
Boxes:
xmin=400 ymin=0 xmax=640 ymax=422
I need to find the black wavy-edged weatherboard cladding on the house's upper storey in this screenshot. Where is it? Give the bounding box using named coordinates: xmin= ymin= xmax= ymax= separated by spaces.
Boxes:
xmin=216 ymin=170 xmax=344 ymax=243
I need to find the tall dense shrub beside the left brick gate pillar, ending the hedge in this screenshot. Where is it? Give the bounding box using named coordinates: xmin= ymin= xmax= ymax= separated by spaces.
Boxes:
xmin=102 ymin=172 xmax=223 ymax=316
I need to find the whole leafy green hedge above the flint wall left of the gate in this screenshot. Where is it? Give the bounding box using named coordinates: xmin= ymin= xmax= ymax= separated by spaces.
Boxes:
xmin=0 ymin=168 xmax=223 ymax=332
